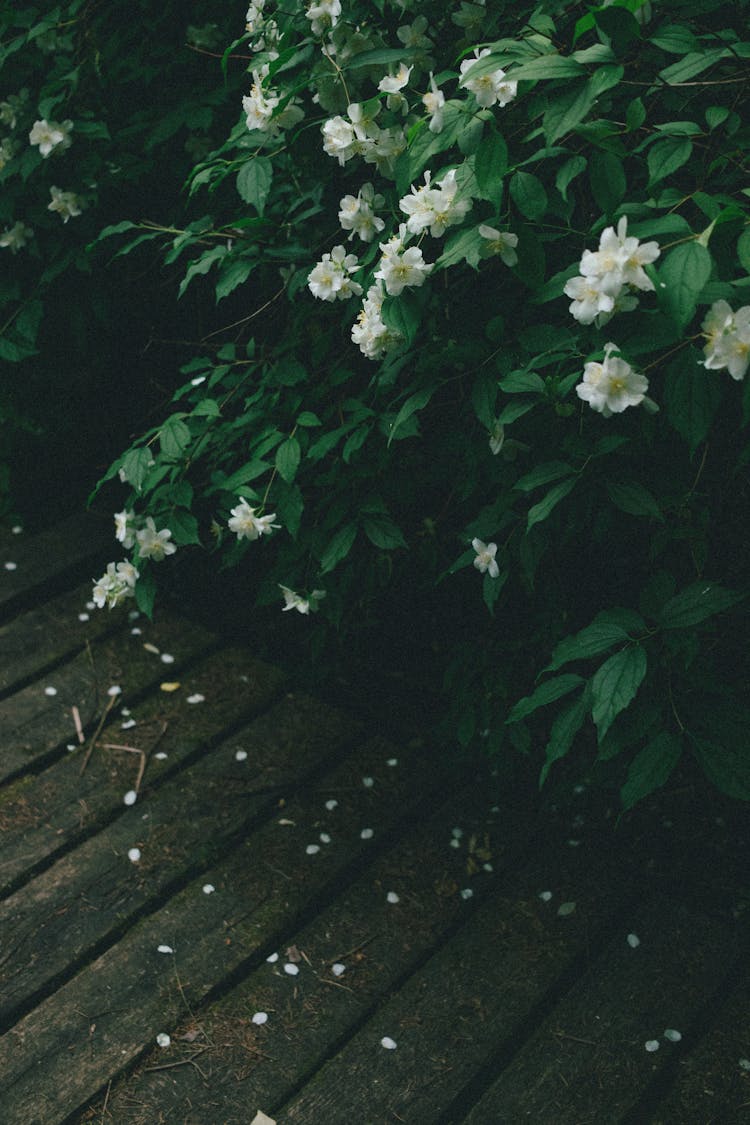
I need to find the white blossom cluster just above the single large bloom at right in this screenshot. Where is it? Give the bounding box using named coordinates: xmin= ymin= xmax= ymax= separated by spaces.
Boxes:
xmin=564 ymin=216 xmax=660 ymax=326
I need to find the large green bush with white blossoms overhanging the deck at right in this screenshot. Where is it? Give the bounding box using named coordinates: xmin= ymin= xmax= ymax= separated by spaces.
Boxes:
xmin=89 ymin=0 xmax=750 ymax=807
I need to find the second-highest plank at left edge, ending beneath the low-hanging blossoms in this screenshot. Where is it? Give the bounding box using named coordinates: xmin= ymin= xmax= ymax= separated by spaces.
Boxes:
xmin=0 ymin=583 xmax=127 ymax=695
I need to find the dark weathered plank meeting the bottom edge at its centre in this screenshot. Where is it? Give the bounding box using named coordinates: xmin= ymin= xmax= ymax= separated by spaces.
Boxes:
xmin=273 ymin=838 xmax=656 ymax=1125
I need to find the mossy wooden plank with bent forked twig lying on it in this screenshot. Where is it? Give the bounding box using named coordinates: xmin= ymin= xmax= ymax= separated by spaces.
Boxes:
xmin=0 ymin=648 xmax=284 ymax=894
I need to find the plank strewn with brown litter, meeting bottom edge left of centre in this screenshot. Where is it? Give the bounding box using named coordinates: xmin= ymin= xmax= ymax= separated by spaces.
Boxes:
xmin=80 ymin=776 xmax=534 ymax=1125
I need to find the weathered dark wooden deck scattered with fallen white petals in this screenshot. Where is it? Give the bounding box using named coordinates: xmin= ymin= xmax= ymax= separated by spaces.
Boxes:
xmin=0 ymin=518 xmax=750 ymax=1125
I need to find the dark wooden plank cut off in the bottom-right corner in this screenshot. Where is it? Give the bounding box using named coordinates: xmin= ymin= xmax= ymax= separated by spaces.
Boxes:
xmin=634 ymin=973 xmax=750 ymax=1125
